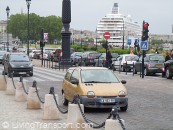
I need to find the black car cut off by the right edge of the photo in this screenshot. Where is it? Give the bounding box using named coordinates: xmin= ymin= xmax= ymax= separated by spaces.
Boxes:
xmin=162 ymin=59 xmax=173 ymax=79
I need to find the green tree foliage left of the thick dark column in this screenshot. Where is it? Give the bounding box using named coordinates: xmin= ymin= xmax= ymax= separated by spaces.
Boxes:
xmin=8 ymin=13 xmax=62 ymax=43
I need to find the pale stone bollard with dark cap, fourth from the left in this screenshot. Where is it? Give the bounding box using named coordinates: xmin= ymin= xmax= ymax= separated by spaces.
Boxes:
xmin=27 ymin=81 xmax=41 ymax=109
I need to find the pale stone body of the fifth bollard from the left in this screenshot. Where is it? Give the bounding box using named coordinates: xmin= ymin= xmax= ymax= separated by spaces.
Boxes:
xmin=43 ymin=94 xmax=59 ymax=120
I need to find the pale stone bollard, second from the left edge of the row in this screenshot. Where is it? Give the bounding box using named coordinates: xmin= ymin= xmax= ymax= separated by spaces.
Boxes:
xmin=6 ymin=75 xmax=16 ymax=95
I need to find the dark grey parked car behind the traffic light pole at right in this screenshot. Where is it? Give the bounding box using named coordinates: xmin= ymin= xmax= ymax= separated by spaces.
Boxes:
xmin=134 ymin=54 xmax=165 ymax=76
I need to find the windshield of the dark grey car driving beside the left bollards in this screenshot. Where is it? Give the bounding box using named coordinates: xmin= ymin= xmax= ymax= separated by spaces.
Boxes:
xmin=10 ymin=55 xmax=29 ymax=62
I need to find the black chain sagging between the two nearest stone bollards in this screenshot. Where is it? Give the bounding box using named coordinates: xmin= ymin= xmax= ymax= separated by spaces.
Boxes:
xmin=76 ymin=97 xmax=112 ymax=129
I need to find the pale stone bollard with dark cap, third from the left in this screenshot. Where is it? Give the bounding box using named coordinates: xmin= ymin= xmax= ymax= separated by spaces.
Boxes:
xmin=15 ymin=77 xmax=27 ymax=102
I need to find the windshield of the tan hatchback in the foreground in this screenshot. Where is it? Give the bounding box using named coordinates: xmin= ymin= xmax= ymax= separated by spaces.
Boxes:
xmin=81 ymin=69 xmax=120 ymax=83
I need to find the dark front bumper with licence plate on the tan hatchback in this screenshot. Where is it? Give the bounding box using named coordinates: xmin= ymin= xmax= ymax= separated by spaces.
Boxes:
xmin=80 ymin=96 xmax=128 ymax=108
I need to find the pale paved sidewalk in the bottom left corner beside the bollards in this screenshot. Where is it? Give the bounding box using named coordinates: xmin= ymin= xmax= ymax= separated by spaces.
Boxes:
xmin=0 ymin=91 xmax=67 ymax=130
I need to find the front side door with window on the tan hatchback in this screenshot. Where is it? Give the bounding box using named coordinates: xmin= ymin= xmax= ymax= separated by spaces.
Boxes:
xmin=68 ymin=69 xmax=79 ymax=101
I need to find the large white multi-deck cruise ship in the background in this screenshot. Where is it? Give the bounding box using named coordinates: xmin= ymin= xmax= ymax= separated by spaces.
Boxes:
xmin=96 ymin=3 xmax=142 ymax=47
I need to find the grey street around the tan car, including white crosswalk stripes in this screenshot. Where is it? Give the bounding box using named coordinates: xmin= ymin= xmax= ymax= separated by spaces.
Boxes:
xmin=0 ymin=65 xmax=173 ymax=130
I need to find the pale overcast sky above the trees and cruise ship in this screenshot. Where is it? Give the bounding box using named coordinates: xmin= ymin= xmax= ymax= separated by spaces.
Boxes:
xmin=0 ymin=0 xmax=173 ymax=34
